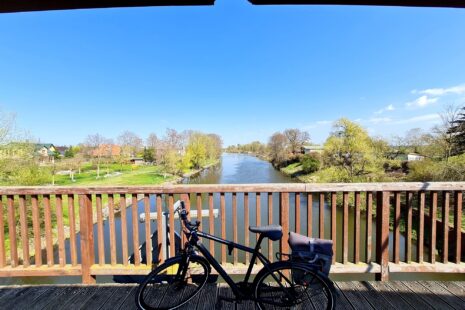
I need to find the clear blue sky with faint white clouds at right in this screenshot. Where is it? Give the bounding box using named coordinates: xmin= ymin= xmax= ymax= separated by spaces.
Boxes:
xmin=0 ymin=0 xmax=465 ymax=145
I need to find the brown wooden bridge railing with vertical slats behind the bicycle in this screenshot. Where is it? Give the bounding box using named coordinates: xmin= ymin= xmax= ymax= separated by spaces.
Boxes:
xmin=0 ymin=182 xmax=465 ymax=283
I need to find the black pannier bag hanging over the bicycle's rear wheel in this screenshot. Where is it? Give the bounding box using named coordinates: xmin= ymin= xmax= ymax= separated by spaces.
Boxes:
xmin=288 ymin=232 xmax=333 ymax=276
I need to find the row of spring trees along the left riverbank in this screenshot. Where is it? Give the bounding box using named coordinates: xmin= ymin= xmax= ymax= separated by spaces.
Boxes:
xmin=0 ymin=110 xmax=223 ymax=185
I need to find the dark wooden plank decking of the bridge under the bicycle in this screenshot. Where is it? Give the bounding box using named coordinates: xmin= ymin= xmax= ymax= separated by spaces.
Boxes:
xmin=0 ymin=281 xmax=465 ymax=310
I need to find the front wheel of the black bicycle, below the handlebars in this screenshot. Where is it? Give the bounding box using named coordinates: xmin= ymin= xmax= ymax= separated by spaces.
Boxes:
xmin=136 ymin=256 xmax=210 ymax=310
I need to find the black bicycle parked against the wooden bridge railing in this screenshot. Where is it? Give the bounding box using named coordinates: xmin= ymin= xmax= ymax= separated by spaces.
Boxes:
xmin=136 ymin=201 xmax=334 ymax=310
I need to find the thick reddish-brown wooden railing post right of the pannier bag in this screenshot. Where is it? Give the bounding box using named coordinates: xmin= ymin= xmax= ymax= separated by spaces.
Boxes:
xmin=376 ymin=192 xmax=390 ymax=281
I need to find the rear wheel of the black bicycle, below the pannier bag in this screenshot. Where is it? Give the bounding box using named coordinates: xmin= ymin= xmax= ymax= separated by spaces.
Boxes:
xmin=255 ymin=262 xmax=334 ymax=310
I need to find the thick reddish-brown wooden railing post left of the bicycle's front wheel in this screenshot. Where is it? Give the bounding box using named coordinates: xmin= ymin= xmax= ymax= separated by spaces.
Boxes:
xmin=79 ymin=195 xmax=95 ymax=284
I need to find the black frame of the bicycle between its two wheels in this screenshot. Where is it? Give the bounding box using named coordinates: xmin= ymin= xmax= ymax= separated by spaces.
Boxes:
xmin=184 ymin=231 xmax=271 ymax=299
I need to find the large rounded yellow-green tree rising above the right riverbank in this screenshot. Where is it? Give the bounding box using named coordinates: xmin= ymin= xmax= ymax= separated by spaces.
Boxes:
xmin=324 ymin=118 xmax=383 ymax=182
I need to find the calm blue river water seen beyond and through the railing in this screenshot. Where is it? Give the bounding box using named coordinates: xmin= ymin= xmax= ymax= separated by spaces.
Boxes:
xmin=5 ymin=153 xmax=452 ymax=284
